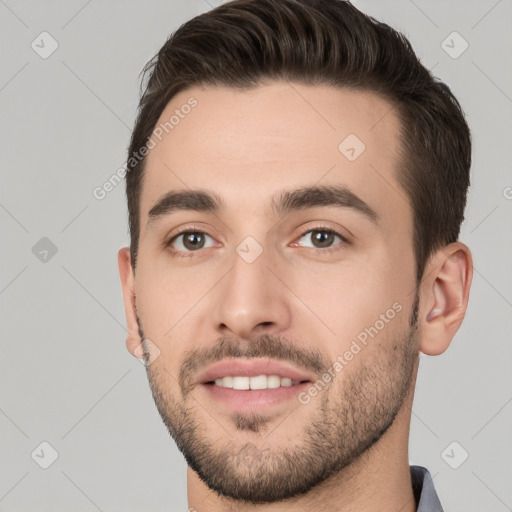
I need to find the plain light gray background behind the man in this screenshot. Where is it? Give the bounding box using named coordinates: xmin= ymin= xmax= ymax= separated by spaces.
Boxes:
xmin=0 ymin=0 xmax=512 ymax=512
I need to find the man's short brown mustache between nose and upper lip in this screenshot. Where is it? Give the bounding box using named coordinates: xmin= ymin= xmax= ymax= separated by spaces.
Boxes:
xmin=178 ymin=334 xmax=330 ymax=397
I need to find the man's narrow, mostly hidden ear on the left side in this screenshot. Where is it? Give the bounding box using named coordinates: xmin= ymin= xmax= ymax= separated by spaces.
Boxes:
xmin=117 ymin=247 xmax=143 ymax=359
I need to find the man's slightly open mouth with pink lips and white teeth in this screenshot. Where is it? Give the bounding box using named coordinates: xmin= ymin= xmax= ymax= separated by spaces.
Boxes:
xmin=200 ymin=359 xmax=314 ymax=412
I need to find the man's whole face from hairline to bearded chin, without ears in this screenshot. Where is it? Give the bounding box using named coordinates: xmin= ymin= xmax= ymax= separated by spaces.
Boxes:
xmin=131 ymin=82 xmax=418 ymax=503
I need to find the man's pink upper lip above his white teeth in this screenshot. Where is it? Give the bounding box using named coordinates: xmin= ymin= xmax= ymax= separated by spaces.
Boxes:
xmin=198 ymin=358 xmax=314 ymax=384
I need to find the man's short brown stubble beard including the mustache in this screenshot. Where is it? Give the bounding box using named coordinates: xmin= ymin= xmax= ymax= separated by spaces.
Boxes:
xmin=139 ymin=296 xmax=419 ymax=504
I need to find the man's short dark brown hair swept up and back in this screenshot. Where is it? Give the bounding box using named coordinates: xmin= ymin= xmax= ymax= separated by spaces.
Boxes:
xmin=126 ymin=0 xmax=471 ymax=281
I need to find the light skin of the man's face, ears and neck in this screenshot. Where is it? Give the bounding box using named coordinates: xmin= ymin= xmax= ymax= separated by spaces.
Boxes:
xmin=118 ymin=82 xmax=472 ymax=512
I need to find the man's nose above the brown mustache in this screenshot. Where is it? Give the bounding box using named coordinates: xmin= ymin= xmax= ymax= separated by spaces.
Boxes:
xmin=213 ymin=243 xmax=291 ymax=339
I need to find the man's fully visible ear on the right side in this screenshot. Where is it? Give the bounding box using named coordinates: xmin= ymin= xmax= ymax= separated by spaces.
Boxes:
xmin=419 ymin=242 xmax=473 ymax=356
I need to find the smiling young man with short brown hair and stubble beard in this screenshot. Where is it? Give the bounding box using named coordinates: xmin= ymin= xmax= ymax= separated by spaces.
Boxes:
xmin=119 ymin=0 xmax=472 ymax=512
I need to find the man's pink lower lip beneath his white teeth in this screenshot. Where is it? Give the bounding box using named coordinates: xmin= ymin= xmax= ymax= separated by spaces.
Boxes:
xmin=202 ymin=382 xmax=311 ymax=411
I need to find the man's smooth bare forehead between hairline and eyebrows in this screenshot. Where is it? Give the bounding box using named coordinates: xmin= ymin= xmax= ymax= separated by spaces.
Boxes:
xmin=140 ymin=82 xmax=412 ymax=229
